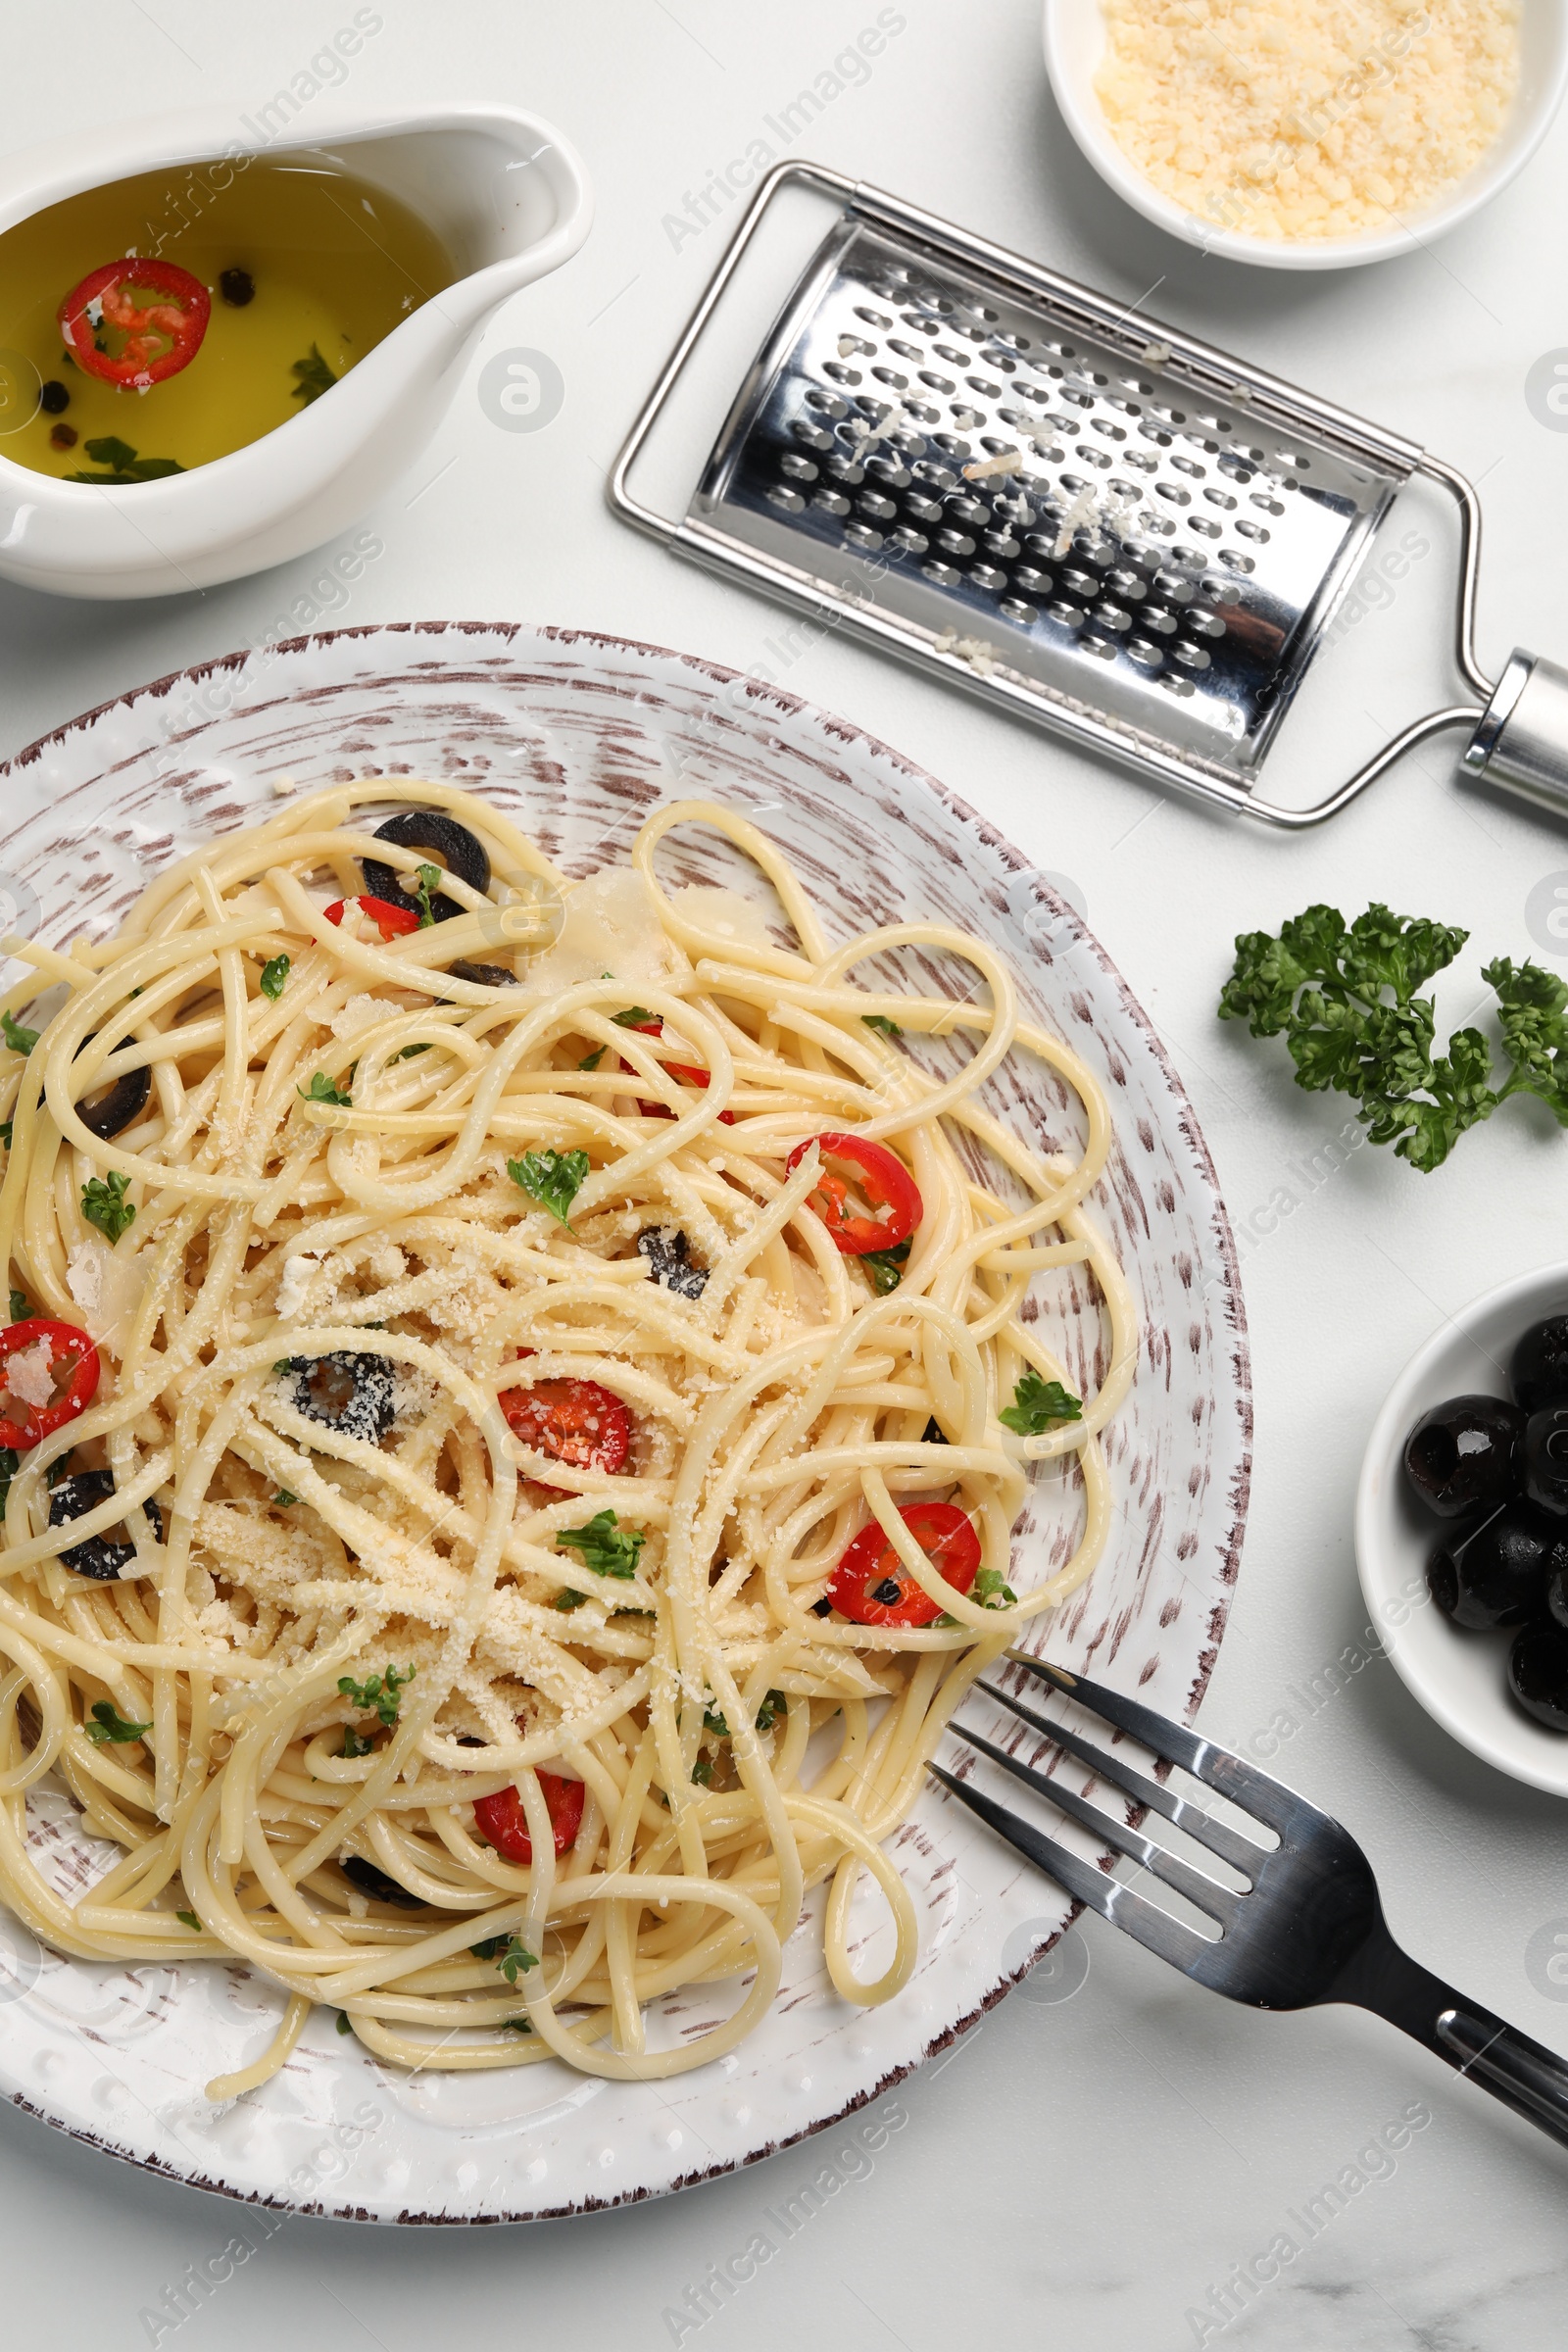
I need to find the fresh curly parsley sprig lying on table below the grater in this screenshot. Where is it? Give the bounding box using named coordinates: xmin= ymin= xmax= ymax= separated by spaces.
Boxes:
xmin=1220 ymin=904 xmax=1568 ymax=1174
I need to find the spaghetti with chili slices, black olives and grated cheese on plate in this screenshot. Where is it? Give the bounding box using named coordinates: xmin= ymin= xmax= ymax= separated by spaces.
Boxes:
xmin=0 ymin=778 xmax=1136 ymax=2098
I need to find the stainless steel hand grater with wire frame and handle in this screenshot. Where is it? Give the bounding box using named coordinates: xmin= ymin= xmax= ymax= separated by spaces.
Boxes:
xmin=609 ymin=163 xmax=1568 ymax=828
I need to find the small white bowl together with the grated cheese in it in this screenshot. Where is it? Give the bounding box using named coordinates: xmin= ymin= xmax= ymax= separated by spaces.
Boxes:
xmin=1046 ymin=0 xmax=1568 ymax=270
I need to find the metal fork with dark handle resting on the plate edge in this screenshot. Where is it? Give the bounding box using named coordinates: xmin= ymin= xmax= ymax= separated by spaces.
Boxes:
xmin=929 ymin=1651 xmax=1568 ymax=2142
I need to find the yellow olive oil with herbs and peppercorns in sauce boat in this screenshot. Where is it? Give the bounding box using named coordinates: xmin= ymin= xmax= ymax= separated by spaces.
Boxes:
xmin=0 ymin=153 xmax=461 ymax=484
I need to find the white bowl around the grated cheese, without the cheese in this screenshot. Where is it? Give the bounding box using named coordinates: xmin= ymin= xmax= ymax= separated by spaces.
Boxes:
xmin=1044 ymin=0 xmax=1568 ymax=270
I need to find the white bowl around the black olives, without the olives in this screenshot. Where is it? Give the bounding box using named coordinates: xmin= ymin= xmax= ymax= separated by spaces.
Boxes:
xmin=1356 ymin=1265 xmax=1568 ymax=1797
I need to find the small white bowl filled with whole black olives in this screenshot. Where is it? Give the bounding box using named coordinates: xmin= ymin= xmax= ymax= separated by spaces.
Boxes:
xmin=1356 ymin=1265 xmax=1568 ymax=1797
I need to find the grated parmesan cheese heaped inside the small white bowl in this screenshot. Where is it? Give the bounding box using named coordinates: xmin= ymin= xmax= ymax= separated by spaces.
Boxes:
xmin=1096 ymin=0 xmax=1519 ymax=240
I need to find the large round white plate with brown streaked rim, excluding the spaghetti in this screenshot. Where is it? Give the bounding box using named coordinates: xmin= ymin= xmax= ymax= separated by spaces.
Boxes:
xmin=0 ymin=623 xmax=1250 ymax=2221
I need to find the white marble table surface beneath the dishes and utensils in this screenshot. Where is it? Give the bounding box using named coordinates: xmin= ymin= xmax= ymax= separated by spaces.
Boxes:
xmin=0 ymin=0 xmax=1568 ymax=2352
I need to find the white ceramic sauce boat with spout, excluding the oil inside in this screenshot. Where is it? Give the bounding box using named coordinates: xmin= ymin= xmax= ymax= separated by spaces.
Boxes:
xmin=0 ymin=106 xmax=592 ymax=598
